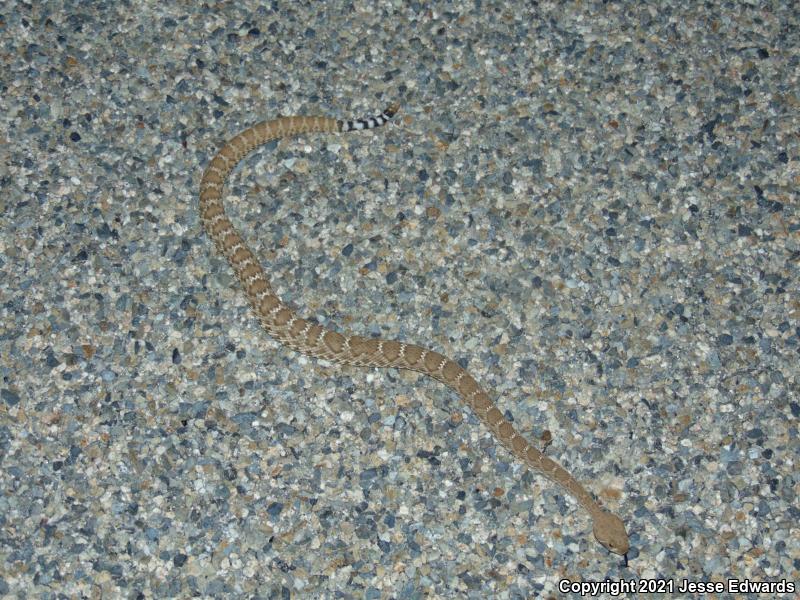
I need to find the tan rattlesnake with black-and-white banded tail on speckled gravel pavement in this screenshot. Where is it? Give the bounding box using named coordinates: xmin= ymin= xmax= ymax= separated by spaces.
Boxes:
xmin=200 ymin=106 xmax=629 ymax=562
